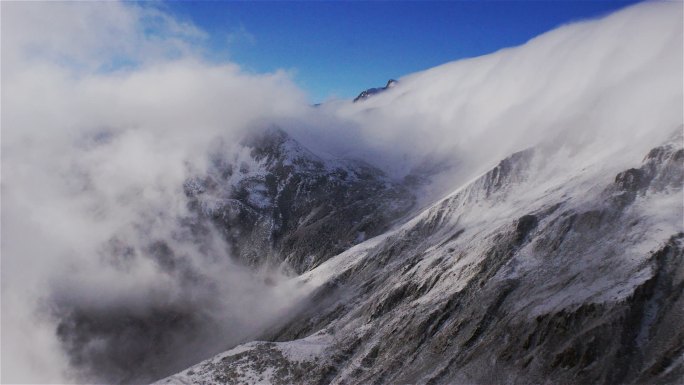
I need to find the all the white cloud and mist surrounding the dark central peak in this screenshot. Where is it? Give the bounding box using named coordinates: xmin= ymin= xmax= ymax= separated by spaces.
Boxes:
xmin=1 ymin=2 xmax=684 ymax=383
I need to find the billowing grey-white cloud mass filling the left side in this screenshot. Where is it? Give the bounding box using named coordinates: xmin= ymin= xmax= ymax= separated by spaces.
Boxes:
xmin=2 ymin=3 xmax=308 ymax=383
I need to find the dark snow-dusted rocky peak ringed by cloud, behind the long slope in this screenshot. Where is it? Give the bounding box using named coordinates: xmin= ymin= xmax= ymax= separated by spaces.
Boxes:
xmin=185 ymin=129 xmax=415 ymax=274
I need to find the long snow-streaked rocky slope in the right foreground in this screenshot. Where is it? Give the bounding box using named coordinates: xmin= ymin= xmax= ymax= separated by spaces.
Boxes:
xmin=159 ymin=133 xmax=684 ymax=384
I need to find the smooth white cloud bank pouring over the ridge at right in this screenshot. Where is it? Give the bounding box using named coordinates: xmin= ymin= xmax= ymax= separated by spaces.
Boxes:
xmin=292 ymin=2 xmax=683 ymax=190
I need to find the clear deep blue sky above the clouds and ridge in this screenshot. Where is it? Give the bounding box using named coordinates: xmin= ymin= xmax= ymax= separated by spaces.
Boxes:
xmin=161 ymin=0 xmax=636 ymax=102
